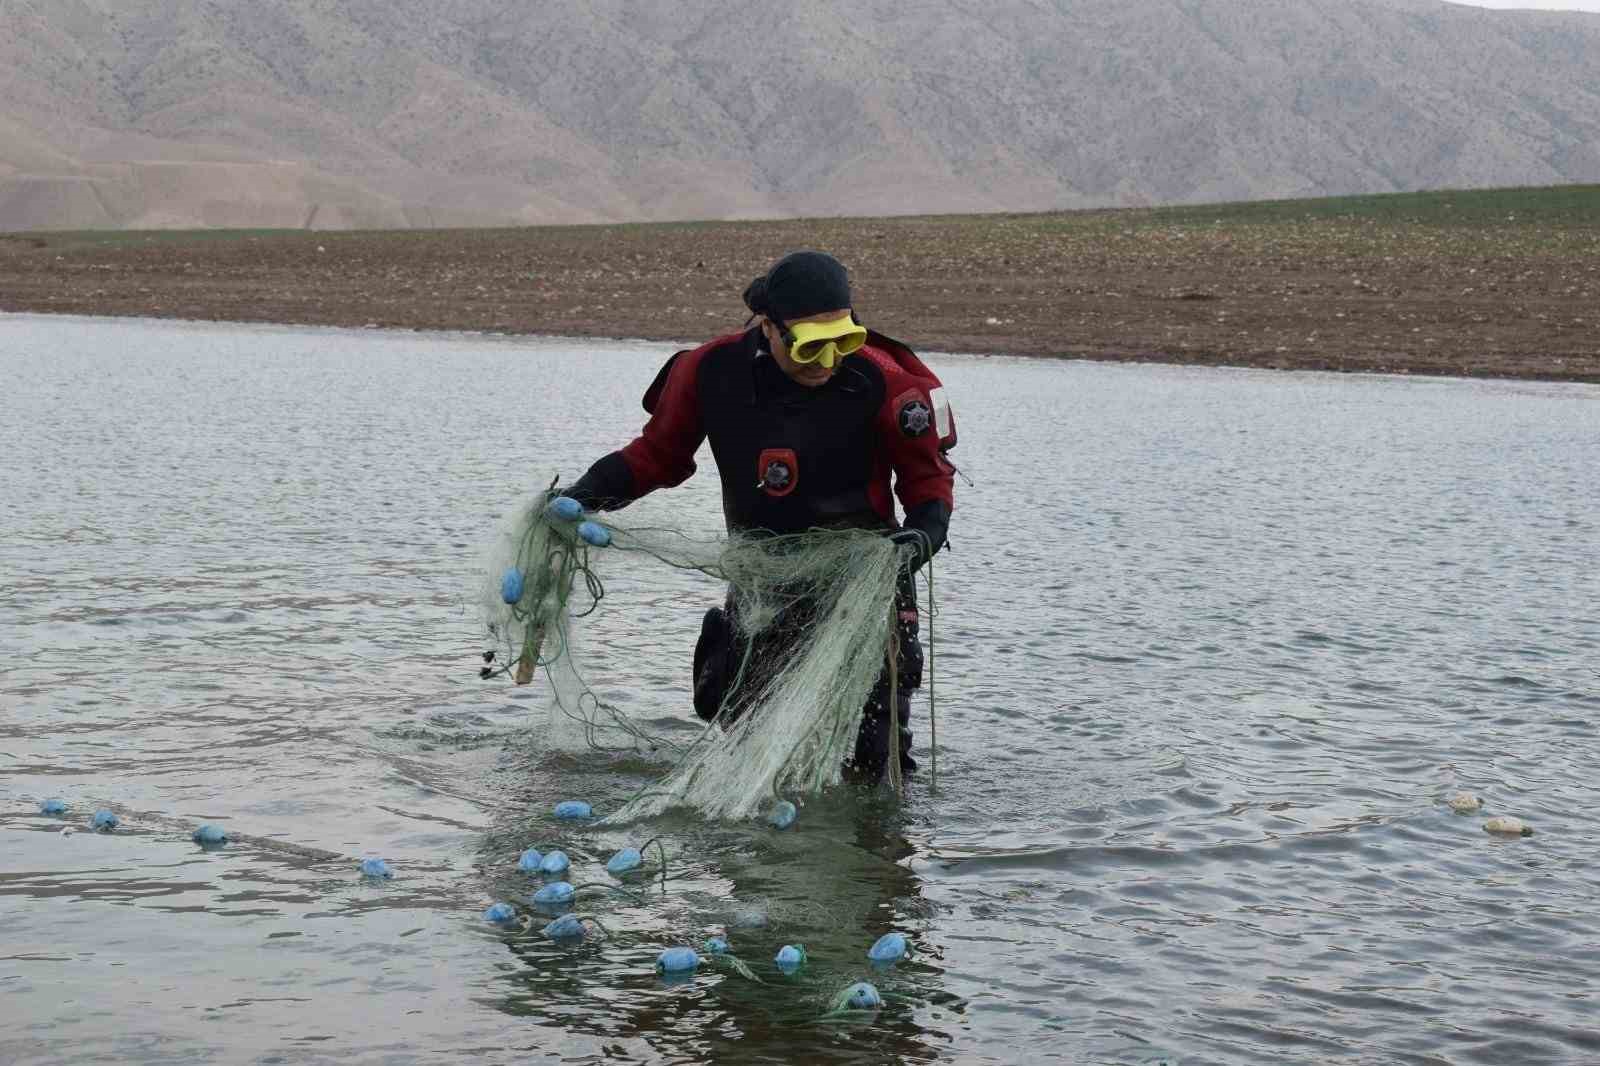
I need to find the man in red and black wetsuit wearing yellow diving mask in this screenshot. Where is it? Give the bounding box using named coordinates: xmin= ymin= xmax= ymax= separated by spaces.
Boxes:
xmin=565 ymin=251 xmax=955 ymax=781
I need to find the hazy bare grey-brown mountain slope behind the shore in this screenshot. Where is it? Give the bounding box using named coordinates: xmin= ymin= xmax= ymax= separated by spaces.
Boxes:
xmin=0 ymin=0 xmax=1600 ymax=229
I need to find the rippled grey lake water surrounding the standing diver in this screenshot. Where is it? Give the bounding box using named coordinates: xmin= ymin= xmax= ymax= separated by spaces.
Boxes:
xmin=0 ymin=315 xmax=1600 ymax=1066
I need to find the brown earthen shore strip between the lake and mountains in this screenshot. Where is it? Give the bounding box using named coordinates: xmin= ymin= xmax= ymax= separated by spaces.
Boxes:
xmin=0 ymin=187 xmax=1600 ymax=383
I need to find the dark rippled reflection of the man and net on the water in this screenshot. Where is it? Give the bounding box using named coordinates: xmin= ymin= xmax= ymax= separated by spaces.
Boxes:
xmin=478 ymin=759 xmax=960 ymax=1061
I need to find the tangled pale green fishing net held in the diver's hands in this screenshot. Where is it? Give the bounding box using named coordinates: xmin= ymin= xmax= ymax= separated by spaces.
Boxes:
xmin=482 ymin=496 xmax=899 ymax=821
